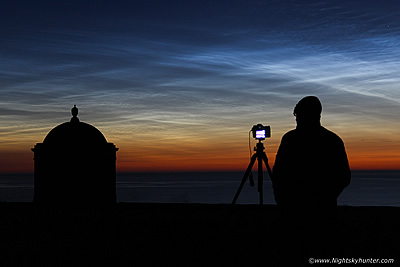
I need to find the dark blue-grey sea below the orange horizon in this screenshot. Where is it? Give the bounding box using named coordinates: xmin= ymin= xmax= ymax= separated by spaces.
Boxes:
xmin=0 ymin=170 xmax=400 ymax=207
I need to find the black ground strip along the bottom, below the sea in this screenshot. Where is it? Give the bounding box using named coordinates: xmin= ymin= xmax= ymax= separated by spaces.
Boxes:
xmin=0 ymin=203 xmax=400 ymax=266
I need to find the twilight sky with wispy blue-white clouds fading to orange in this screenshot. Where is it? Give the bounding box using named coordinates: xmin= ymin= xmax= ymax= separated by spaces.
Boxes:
xmin=0 ymin=0 xmax=400 ymax=170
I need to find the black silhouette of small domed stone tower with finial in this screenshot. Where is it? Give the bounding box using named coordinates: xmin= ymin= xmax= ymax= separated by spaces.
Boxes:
xmin=32 ymin=105 xmax=118 ymax=205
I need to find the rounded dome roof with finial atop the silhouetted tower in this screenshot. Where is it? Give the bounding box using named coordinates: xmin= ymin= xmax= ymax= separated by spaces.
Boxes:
xmin=43 ymin=106 xmax=107 ymax=146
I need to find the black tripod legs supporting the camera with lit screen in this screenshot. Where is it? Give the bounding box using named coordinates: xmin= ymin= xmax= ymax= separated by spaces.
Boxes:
xmin=232 ymin=140 xmax=272 ymax=205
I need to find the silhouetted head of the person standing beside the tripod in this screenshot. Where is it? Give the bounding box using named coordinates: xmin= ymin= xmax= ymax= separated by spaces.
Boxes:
xmin=293 ymin=96 xmax=322 ymax=126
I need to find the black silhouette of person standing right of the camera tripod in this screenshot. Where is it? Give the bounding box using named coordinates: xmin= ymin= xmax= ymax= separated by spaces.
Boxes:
xmin=273 ymin=96 xmax=351 ymax=208
